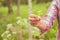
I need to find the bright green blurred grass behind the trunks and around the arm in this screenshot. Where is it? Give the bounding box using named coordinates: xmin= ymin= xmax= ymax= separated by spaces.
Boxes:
xmin=0 ymin=2 xmax=57 ymax=40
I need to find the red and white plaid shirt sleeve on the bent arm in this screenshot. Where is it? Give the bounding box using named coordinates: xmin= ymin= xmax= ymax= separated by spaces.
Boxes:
xmin=39 ymin=1 xmax=58 ymax=33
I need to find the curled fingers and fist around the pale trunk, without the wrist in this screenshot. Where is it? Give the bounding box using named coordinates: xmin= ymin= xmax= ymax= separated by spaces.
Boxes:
xmin=29 ymin=14 xmax=41 ymax=26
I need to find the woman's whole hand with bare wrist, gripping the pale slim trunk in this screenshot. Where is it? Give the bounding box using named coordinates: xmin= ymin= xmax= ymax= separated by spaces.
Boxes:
xmin=29 ymin=14 xmax=46 ymax=30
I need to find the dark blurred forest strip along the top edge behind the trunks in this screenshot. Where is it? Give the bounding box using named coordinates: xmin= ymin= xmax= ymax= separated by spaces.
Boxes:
xmin=0 ymin=0 xmax=52 ymax=6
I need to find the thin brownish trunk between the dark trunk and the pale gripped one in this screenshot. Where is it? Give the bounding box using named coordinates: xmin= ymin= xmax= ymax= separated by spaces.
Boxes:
xmin=17 ymin=0 xmax=23 ymax=40
